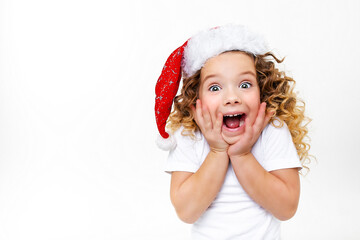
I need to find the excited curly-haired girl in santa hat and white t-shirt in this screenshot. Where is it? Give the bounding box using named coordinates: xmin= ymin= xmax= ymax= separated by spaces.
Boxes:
xmin=155 ymin=25 xmax=309 ymax=240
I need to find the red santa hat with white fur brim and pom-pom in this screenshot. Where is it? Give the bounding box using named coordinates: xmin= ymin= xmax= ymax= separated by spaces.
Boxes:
xmin=155 ymin=25 xmax=269 ymax=150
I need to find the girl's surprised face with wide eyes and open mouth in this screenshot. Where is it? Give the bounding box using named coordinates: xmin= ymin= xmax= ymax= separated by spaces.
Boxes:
xmin=199 ymin=51 xmax=260 ymax=144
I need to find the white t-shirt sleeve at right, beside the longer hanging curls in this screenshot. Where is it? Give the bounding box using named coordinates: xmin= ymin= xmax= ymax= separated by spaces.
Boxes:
xmin=262 ymin=123 xmax=302 ymax=172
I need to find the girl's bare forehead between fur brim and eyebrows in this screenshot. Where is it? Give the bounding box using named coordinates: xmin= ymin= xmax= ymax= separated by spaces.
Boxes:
xmin=201 ymin=51 xmax=256 ymax=78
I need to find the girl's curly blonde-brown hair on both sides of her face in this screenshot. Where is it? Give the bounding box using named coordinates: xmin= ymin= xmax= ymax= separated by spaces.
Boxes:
xmin=167 ymin=52 xmax=311 ymax=170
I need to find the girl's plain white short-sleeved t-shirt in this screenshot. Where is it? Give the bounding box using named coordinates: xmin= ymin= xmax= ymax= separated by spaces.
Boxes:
xmin=165 ymin=123 xmax=301 ymax=240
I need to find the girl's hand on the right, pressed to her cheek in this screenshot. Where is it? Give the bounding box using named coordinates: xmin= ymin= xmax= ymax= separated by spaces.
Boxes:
xmin=228 ymin=102 xmax=273 ymax=158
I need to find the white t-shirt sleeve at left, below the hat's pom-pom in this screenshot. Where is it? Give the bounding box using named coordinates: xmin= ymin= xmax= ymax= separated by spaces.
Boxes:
xmin=165 ymin=128 xmax=201 ymax=173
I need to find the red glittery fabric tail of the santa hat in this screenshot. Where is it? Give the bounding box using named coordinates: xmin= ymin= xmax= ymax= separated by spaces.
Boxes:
xmin=155 ymin=41 xmax=187 ymax=138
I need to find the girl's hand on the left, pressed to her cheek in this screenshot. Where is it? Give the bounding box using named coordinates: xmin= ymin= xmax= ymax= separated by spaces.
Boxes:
xmin=191 ymin=99 xmax=229 ymax=152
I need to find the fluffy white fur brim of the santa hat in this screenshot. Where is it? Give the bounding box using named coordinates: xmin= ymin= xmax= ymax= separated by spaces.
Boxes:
xmin=182 ymin=25 xmax=269 ymax=76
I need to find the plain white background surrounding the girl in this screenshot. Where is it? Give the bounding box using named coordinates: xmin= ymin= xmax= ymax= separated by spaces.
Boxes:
xmin=0 ymin=0 xmax=360 ymax=240
